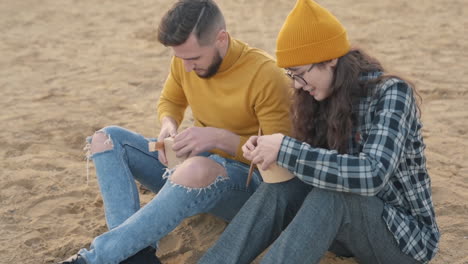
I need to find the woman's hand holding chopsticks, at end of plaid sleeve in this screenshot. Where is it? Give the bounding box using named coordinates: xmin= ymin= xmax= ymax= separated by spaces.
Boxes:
xmin=242 ymin=134 xmax=284 ymax=170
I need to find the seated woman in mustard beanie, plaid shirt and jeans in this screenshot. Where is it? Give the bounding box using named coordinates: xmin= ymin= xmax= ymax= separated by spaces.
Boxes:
xmin=200 ymin=0 xmax=440 ymax=263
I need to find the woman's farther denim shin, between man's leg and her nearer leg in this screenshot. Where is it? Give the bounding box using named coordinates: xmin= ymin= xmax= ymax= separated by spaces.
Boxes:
xmin=199 ymin=178 xmax=311 ymax=263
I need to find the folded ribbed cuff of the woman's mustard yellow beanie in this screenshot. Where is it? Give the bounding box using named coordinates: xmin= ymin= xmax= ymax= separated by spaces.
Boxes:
xmin=276 ymin=31 xmax=350 ymax=68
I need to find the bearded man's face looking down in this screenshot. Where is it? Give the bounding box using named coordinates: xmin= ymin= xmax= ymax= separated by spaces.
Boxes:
xmin=172 ymin=34 xmax=223 ymax=78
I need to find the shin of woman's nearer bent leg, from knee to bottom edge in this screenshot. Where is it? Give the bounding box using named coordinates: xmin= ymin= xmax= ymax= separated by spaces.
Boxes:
xmin=261 ymin=188 xmax=348 ymax=263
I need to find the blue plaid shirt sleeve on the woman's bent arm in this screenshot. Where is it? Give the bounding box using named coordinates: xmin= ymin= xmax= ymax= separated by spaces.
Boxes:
xmin=278 ymin=82 xmax=416 ymax=196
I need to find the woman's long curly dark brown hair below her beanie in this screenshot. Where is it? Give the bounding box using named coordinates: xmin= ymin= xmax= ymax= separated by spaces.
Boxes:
xmin=291 ymin=48 xmax=415 ymax=154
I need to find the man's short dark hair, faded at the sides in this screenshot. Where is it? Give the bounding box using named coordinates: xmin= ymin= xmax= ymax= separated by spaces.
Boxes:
xmin=158 ymin=0 xmax=226 ymax=46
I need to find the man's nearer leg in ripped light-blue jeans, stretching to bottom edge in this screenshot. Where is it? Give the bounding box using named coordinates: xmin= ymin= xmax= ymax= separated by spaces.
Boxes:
xmin=79 ymin=154 xmax=258 ymax=264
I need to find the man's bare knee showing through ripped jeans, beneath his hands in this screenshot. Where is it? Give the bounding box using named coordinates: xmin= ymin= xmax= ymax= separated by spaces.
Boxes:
xmin=170 ymin=157 xmax=227 ymax=188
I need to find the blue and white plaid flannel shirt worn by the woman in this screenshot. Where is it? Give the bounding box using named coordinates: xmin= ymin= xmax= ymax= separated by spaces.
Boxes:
xmin=277 ymin=72 xmax=440 ymax=263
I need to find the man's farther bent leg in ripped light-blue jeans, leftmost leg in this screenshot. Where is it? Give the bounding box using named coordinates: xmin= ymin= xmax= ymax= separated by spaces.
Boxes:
xmin=89 ymin=126 xmax=165 ymax=230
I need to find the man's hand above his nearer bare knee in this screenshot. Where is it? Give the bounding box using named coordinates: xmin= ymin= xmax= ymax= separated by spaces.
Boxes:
xmin=172 ymin=127 xmax=240 ymax=157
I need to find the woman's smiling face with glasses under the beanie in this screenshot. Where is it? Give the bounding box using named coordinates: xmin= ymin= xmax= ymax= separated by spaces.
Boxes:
xmin=287 ymin=59 xmax=338 ymax=101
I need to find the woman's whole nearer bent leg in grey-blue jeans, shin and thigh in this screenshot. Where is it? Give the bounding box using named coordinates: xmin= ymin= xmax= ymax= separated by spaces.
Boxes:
xmin=262 ymin=188 xmax=418 ymax=264
